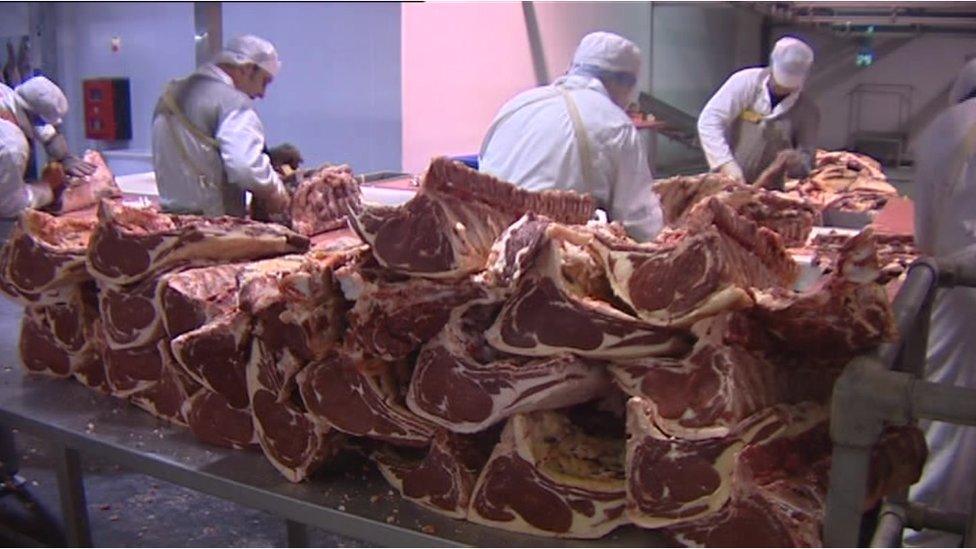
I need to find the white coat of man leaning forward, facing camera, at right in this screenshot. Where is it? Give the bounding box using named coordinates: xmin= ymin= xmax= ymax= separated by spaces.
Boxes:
xmin=698 ymin=67 xmax=820 ymax=180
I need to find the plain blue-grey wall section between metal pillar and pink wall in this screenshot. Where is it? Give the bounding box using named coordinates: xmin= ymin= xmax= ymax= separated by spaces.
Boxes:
xmin=223 ymin=2 xmax=400 ymax=172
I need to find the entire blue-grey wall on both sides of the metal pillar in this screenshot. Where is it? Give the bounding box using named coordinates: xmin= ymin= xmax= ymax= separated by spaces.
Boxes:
xmin=48 ymin=2 xmax=401 ymax=174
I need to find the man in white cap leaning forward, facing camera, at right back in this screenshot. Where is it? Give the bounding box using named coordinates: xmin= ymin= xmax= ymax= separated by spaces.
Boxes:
xmin=698 ymin=36 xmax=820 ymax=183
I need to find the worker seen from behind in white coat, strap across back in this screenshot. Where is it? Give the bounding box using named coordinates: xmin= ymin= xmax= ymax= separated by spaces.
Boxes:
xmin=479 ymin=32 xmax=663 ymax=241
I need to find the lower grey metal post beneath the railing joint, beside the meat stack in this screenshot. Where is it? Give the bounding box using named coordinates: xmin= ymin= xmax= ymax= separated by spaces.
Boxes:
xmin=823 ymin=443 xmax=871 ymax=547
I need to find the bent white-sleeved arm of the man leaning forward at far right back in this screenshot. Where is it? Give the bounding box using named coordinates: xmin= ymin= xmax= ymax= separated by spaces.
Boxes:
xmin=698 ymin=71 xmax=754 ymax=170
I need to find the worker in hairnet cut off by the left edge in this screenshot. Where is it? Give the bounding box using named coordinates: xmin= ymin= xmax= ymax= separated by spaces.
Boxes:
xmin=0 ymin=76 xmax=95 ymax=217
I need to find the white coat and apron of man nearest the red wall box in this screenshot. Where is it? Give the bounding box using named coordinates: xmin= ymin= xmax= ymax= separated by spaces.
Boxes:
xmin=153 ymin=63 xmax=283 ymax=216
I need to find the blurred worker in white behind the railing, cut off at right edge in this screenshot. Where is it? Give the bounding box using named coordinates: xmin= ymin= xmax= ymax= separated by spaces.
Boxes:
xmin=905 ymin=60 xmax=976 ymax=547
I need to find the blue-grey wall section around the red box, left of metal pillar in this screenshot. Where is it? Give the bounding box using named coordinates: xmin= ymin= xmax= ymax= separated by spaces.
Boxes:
xmin=55 ymin=2 xmax=194 ymax=175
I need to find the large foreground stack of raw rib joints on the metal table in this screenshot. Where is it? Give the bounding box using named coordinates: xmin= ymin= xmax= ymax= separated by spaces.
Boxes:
xmin=0 ymin=159 xmax=925 ymax=545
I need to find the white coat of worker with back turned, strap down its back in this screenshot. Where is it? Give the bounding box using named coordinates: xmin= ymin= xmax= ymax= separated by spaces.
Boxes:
xmin=479 ymin=75 xmax=664 ymax=241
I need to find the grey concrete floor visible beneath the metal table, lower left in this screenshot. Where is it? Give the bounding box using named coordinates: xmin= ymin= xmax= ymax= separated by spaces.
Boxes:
xmin=0 ymin=432 xmax=368 ymax=547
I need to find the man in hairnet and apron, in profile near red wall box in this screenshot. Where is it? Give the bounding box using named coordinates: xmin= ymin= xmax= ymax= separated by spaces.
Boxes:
xmin=153 ymin=35 xmax=297 ymax=217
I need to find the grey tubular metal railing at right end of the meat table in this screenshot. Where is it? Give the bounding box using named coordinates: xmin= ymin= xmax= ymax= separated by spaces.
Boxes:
xmin=823 ymin=245 xmax=976 ymax=547
